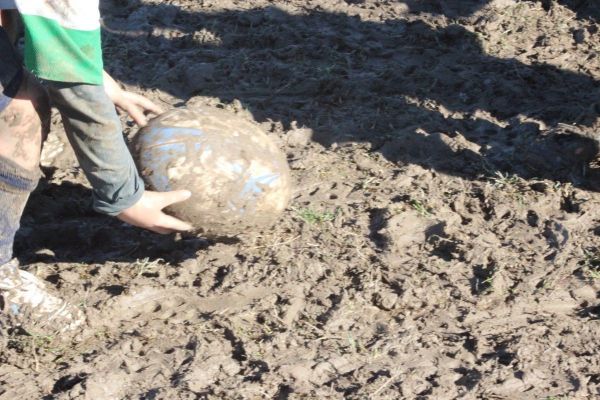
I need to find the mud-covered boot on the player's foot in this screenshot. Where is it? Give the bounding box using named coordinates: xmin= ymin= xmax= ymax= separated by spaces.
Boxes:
xmin=0 ymin=260 xmax=85 ymax=335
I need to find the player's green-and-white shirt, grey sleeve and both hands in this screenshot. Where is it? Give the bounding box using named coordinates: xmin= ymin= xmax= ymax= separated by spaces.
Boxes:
xmin=14 ymin=0 xmax=190 ymax=233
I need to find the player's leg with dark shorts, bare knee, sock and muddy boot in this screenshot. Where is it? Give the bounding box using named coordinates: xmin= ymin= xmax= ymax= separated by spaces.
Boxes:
xmin=0 ymin=27 xmax=83 ymax=332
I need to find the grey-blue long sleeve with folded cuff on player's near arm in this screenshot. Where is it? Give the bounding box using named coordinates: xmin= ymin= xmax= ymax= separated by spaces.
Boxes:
xmin=45 ymin=81 xmax=144 ymax=215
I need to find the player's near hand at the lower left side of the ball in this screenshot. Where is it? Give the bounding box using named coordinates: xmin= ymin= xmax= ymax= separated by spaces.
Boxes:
xmin=117 ymin=190 xmax=193 ymax=234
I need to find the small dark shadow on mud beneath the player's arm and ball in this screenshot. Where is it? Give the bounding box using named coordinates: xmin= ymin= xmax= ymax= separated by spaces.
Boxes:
xmin=14 ymin=169 xmax=210 ymax=265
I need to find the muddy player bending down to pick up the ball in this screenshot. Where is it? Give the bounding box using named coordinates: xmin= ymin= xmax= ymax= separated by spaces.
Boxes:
xmin=0 ymin=0 xmax=191 ymax=332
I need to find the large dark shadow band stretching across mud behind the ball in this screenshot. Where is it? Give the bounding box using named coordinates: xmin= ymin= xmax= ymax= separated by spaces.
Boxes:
xmin=103 ymin=0 xmax=600 ymax=188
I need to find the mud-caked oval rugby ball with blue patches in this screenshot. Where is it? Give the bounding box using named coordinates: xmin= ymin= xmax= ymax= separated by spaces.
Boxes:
xmin=134 ymin=106 xmax=291 ymax=237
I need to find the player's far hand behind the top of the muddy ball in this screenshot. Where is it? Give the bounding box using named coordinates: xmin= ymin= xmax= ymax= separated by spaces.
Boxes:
xmin=104 ymin=72 xmax=163 ymax=126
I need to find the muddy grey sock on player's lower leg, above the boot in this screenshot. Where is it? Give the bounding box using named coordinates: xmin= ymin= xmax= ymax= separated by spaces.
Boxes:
xmin=0 ymin=156 xmax=40 ymax=267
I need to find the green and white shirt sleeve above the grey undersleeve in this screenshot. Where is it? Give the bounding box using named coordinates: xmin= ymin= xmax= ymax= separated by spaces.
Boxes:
xmin=0 ymin=0 xmax=103 ymax=85
